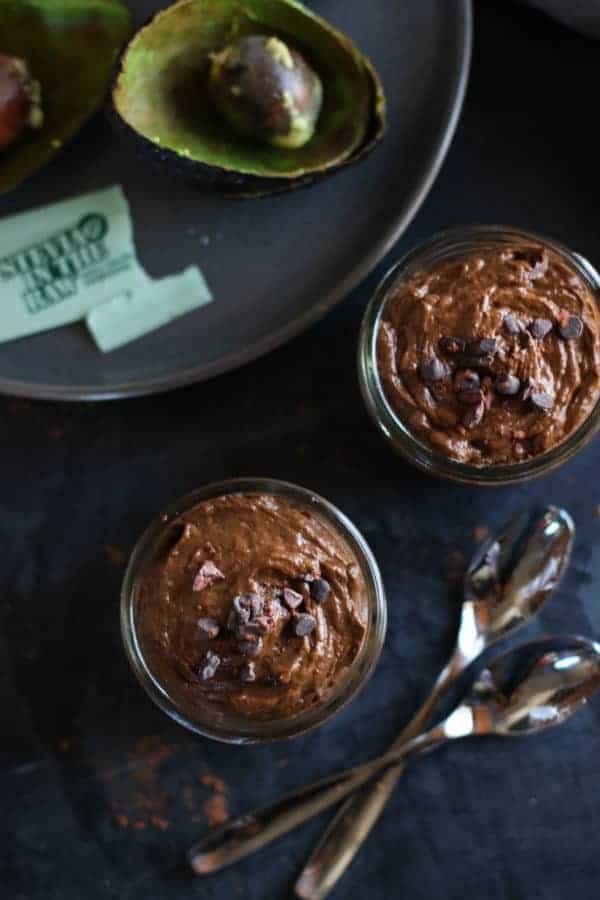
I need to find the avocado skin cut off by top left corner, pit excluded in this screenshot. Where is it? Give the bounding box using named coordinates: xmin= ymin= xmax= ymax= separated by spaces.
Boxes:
xmin=0 ymin=0 xmax=132 ymax=193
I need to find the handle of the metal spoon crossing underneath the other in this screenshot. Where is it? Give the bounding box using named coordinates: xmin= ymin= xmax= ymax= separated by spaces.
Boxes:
xmin=294 ymin=650 xmax=469 ymax=900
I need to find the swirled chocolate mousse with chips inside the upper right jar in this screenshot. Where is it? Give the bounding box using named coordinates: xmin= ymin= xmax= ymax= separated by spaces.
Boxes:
xmin=377 ymin=243 xmax=600 ymax=466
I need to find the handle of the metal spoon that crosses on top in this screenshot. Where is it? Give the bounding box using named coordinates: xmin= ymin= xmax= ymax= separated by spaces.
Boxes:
xmin=188 ymin=723 xmax=448 ymax=875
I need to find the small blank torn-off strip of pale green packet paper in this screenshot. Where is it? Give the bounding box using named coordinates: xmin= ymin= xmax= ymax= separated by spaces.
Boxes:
xmin=86 ymin=266 xmax=213 ymax=353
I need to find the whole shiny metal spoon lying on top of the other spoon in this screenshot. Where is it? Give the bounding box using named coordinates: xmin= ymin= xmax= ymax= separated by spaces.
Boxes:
xmin=189 ymin=638 xmax=600 ymax=875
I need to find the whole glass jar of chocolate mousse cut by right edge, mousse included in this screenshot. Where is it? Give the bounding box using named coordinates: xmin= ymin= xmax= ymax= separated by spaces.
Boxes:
xmin=358 ymin=226 xmax=600 ymax=485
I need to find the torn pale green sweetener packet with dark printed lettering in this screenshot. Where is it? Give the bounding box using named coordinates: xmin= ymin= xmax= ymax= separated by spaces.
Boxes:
xmin=0 ymin=187 xmax=152 ymax=342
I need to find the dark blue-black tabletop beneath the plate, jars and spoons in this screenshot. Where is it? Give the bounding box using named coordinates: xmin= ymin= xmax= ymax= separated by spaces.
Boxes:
xmin=0 ymin=0 xmax=600 ymax=900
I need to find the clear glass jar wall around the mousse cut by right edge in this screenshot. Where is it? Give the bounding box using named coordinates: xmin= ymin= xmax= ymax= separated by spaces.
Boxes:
xmin=358 ymin=225 xmax=600 ymax=486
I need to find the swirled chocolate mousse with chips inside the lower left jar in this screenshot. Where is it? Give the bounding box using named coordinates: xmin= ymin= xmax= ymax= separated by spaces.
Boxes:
xmin=136 ymin=494 xmax=367 ymax=720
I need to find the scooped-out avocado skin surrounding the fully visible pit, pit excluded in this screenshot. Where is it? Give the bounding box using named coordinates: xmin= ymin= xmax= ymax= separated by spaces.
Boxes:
xmin=112 ymin=0 xmax=385 ymax=195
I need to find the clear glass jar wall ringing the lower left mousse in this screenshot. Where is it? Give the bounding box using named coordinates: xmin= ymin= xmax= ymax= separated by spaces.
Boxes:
xmin=121 ymin=478 xmax=387 ymax=744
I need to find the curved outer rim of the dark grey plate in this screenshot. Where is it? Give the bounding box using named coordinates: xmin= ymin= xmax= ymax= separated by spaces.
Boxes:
xmin=0 ymin=0 xmax=473 ymax=402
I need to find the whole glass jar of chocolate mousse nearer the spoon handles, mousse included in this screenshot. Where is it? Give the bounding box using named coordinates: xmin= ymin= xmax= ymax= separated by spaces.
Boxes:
xmin=121 ymin=478 xmax=387 ymax=744
